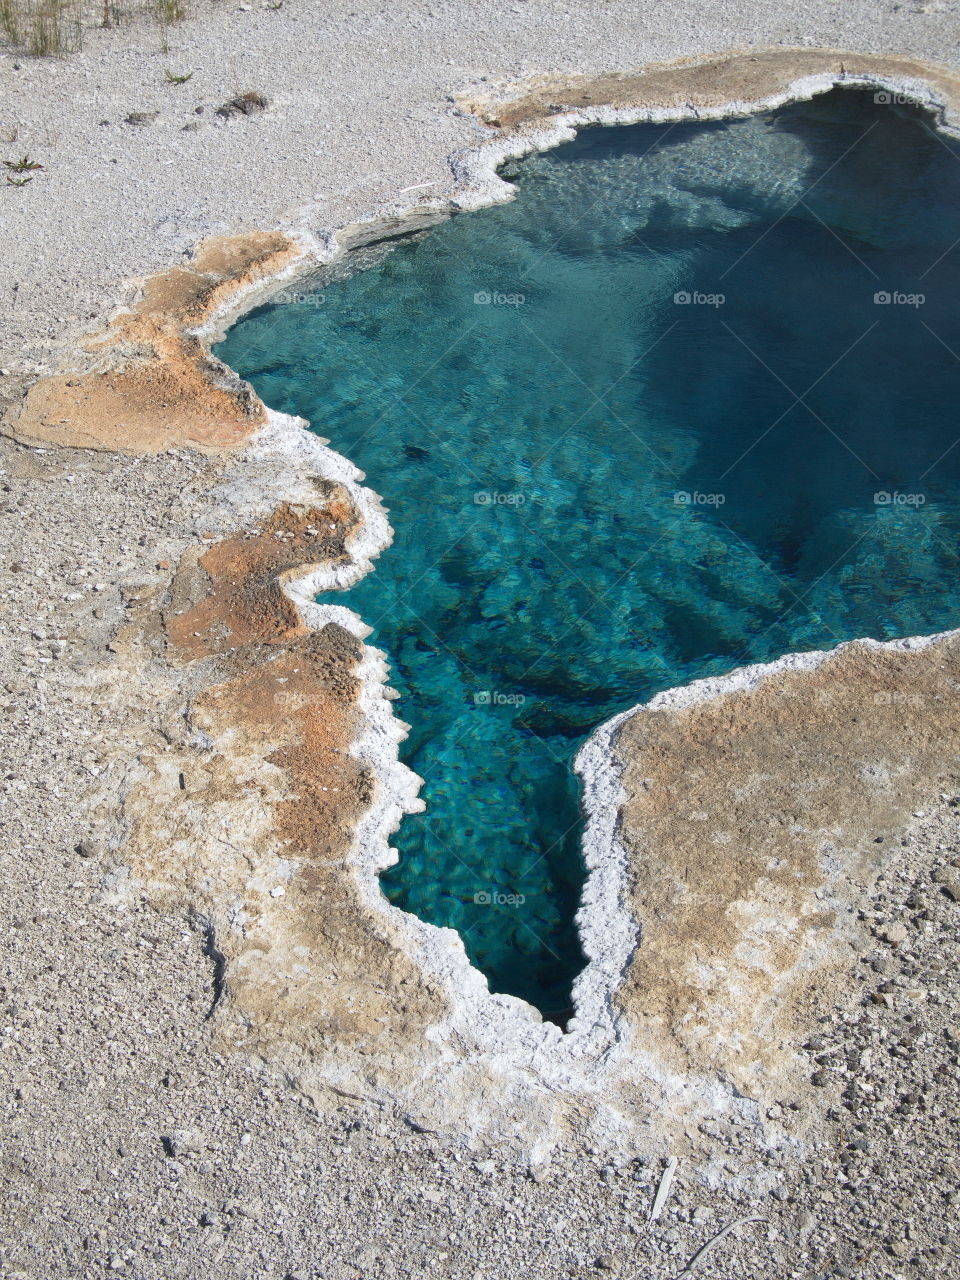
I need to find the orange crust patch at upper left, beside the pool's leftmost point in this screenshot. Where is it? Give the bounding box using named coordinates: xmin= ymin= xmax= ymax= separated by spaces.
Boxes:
xmin=12 ymin=232 xmax=303 ymax=453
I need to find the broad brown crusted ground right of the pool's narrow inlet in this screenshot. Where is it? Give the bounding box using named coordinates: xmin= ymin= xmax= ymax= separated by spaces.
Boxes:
xmin=614 ymin=632 xmax=960 ymax=1101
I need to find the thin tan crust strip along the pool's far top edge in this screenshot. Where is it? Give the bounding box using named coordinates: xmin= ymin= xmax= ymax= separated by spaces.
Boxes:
xmin=457 ymin=49 xmax=960 ymax=133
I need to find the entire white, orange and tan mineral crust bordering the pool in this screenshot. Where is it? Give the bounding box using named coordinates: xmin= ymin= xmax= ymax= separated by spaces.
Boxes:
xmin=13 ymin=50 xmax=960 ymax=1149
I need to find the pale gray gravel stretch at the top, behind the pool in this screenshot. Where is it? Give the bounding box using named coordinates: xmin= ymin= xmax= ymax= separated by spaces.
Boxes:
xmin=0 ymin=0 xmax=960 ymax=369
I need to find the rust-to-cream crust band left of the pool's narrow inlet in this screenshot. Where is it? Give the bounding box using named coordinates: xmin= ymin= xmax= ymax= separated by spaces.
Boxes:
xmin=113 ymin=481 xmax=449 ymax=1093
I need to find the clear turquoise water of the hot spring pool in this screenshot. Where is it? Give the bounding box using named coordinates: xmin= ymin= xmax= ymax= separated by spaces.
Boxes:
xmin=218 ymin=91 xmax=960 ymax=1021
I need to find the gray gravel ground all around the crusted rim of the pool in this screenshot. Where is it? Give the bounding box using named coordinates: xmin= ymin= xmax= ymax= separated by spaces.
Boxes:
xmin=0 ymin=0 xmax=960 ymax=1280
